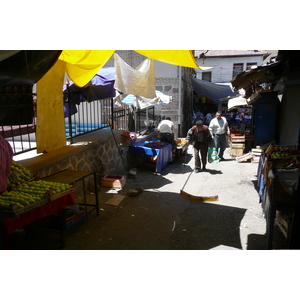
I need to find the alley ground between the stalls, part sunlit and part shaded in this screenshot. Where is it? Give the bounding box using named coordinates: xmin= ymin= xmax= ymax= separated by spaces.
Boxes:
xmin=8 ymin=147 xmax=287 ymax=250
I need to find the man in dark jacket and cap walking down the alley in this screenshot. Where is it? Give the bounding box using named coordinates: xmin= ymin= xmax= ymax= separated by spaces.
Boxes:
xmin=186 ymin=120 xmax=212 ymax=173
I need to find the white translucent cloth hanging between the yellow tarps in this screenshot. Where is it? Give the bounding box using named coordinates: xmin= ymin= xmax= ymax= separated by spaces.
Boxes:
xmin=114 ymin=53 xmax=156 ymax=98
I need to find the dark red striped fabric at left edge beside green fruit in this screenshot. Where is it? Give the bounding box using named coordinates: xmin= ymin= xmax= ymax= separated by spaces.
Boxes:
xmin=0 ymin=135 xmax=13 ymax=194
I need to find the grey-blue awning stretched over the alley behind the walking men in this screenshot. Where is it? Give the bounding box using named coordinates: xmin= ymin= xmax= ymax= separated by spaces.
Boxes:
xmin=191 ymin=78 xmax=239 ymax=103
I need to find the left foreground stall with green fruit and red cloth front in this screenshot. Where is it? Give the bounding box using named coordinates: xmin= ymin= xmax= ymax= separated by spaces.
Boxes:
xmin=0 ymin=161 xmax=76 ymax=249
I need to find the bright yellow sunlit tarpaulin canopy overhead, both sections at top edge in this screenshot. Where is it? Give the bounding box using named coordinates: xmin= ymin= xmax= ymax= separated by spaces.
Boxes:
xmin=59 ymin=50 xmax=199 ymax=87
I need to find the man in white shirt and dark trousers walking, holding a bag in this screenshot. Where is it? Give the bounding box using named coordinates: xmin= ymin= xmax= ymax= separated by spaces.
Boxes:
xmin=208 ymin=111 xmax=230 ymax=161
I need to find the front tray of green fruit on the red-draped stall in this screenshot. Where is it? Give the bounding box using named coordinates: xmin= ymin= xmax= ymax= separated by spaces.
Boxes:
xmin=0 ymin=180 xmax=72 ymax=209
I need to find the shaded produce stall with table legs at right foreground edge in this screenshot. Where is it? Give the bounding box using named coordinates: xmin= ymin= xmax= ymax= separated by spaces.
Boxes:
xmin=257 ymin=145 xmax=300 ymax=249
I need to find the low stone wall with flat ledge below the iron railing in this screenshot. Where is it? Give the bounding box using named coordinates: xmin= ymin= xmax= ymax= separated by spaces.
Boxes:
xmin=19 ymin=129 xmax=129 ymax=193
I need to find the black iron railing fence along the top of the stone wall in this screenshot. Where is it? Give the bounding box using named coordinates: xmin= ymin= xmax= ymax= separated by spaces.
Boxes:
xmin=0 ymin=90 xmax=159 ymax=155
